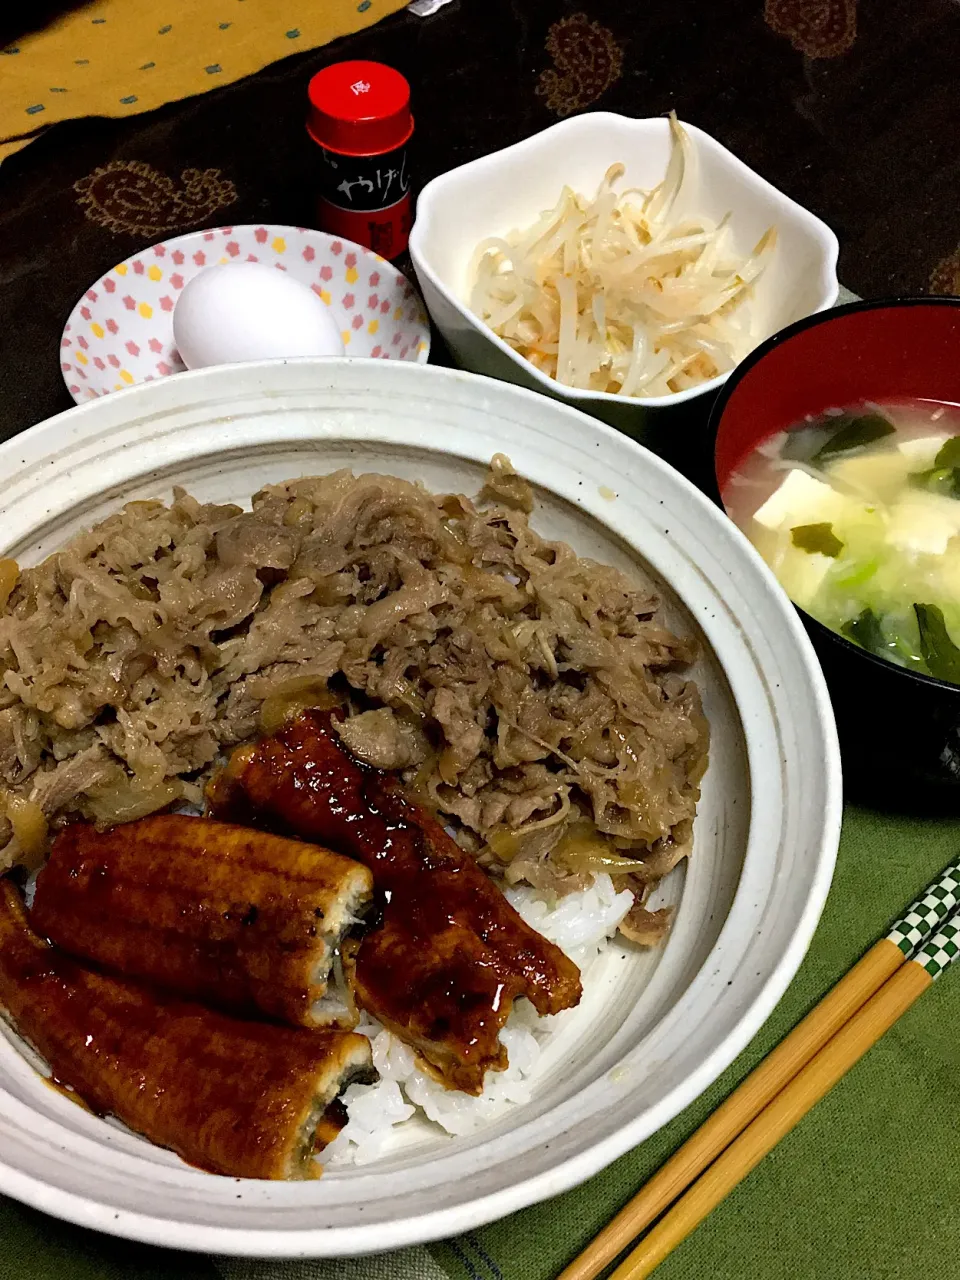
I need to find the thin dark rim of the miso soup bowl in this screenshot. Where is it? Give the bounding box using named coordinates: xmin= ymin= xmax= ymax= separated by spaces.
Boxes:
xmin=707 ymin=293 xmax=960 ymax=695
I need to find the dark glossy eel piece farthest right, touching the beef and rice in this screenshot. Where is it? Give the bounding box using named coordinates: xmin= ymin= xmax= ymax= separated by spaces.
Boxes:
xmin=209 ymin=710 xmax=581 ymax=1094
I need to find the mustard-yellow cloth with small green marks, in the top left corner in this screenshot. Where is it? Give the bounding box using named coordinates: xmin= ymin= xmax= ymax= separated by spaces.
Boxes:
xmin=0 ymin=0 xmax=407 ymax=160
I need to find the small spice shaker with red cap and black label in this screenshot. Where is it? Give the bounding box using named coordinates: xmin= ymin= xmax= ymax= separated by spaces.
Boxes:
xmin=307 ymin=61 xmax=413 ymax=257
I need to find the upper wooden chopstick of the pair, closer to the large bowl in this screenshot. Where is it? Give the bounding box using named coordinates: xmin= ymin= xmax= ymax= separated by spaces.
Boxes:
xmin=557 ymin=861 xmax=960 ymax=1280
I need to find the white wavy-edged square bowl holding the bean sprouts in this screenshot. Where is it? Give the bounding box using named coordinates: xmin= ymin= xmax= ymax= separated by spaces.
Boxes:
xmin=410 ymin=111 xmax=838 ymax=449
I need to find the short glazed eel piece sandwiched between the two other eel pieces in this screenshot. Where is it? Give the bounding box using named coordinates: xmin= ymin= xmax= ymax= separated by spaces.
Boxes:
xmin=31 ymin=814 xmax=372 ymax=1027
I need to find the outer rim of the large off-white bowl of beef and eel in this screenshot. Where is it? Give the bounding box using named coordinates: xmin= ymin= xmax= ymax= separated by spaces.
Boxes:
xmin=0 ymin=357 xmax=841 ymax=1257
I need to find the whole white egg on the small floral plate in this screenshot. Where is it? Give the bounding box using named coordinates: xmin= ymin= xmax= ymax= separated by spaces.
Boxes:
xmin=173 ymin=262 xmax=343 ymax=369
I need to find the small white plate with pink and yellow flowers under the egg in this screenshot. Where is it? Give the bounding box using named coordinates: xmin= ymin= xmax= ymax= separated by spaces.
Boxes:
xmin=60 ymin=225 xmax=430 ymax=404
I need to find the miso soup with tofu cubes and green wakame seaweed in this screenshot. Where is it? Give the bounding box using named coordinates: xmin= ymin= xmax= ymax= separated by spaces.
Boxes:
xmin=722 ymin=401 xmax=960 ymax=685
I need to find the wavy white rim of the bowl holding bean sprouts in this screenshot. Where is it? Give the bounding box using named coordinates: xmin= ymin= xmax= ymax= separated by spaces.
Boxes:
xmin=410 ymin=111 xmax=840 ymax=408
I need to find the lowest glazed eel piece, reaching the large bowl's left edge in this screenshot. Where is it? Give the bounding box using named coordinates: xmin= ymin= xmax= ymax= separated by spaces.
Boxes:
xmin=0 ymin=881 xmax=376 ymax=1179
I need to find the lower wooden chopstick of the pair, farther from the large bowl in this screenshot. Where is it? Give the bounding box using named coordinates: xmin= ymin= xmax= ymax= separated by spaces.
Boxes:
xmin=611 ymin=915 xmax=960 ymax=1280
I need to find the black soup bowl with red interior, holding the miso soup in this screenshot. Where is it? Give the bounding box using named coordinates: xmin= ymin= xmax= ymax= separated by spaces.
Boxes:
xmin=712 ymin=298 xmax=960 ymax=809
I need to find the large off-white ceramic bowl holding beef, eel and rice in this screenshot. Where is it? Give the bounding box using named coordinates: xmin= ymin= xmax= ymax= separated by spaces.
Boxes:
xmin=0 ymin=360 xmax=840 ymax=1257
